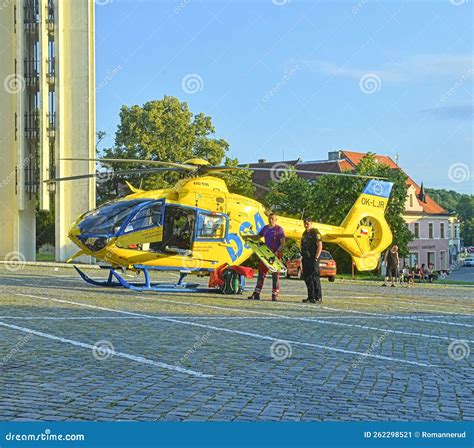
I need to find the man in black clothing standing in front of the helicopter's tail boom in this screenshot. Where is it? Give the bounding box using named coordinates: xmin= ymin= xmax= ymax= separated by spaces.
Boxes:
xmin=301 ymin=218 xmax=323 ymax=303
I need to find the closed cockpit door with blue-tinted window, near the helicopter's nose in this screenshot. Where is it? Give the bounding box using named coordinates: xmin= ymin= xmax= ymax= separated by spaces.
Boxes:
xmin=116 ymin=201 xmax=163 ymax=251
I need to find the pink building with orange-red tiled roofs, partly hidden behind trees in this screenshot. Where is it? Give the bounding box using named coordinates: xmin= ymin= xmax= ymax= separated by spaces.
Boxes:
xmin=250 ymin=150 xmax=453 ymax=271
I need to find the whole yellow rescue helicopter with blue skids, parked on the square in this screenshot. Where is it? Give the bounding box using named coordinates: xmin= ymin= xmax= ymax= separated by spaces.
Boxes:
xmin=50 ymin=159 xmax=393 ymax=291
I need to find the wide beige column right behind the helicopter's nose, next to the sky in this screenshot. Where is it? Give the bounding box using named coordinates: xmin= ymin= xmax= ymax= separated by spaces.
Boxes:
xmin=55 ymin=0 xmax=95 ymax=261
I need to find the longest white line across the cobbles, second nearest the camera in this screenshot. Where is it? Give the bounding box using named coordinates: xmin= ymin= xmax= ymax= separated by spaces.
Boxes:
xmin=15 ymin=294 xmax=432 ymax=367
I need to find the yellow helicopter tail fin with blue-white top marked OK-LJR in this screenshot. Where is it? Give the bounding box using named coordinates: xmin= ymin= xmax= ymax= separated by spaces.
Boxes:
xmin=334 ymin=179 xmax=393 ymax=271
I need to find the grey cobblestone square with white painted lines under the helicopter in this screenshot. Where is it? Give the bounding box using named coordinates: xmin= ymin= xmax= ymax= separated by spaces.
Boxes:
xmin=0 ymin=266 xmax=474 ymax=421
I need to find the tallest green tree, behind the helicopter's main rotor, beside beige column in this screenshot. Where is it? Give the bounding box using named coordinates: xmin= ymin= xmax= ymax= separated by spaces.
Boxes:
xmin=98 ymin=96 xmax=255 ymax=202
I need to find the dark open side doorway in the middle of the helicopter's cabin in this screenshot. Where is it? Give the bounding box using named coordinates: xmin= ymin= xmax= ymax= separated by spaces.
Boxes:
xmin=159 ymin=204 xmax=196 ymax=255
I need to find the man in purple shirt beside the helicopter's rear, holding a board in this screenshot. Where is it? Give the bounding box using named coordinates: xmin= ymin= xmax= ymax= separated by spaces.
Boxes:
xmin=246 ymin=213 xmax=286 ymax=302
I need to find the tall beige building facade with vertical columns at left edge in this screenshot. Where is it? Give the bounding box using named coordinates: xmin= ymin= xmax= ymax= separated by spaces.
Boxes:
xmin=0 ymin=0 xmax=95 ymax=261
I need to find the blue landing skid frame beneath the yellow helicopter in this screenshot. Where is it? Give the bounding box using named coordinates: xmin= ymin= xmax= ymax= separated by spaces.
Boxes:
xmin=74 ymin=266 xmax=216 ymax=292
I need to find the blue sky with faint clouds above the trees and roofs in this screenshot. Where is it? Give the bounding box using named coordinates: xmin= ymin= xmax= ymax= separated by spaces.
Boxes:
xmin=95 ymin=0 xmax=474 ymax=194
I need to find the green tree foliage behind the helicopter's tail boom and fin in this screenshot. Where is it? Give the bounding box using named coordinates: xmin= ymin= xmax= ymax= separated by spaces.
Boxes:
xmin=266 ymin=153 xmax=413 ymax=271
